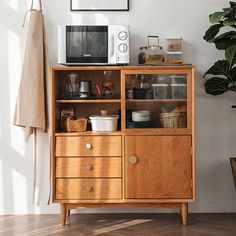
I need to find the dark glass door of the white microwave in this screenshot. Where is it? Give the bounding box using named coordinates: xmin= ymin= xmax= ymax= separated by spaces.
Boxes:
xmin=67 ymin=26 xmax=108 ymax=64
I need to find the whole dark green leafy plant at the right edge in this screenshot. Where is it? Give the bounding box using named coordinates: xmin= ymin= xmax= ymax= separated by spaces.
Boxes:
xmin=203 ymin=1 xmax=236 ymax=95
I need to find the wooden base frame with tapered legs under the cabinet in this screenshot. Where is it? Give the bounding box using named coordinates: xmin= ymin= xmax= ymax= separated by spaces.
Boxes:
xmin=61 ymin=203 xmax=188 ymax=226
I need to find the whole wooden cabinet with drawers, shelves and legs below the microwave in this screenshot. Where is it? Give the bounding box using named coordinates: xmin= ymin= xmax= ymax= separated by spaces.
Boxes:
xmin=51 ymin=66 xmax=196 ymax=225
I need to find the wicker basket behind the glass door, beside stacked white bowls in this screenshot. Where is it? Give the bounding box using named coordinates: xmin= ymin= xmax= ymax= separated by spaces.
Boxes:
xmin=160 ymin=112 xmax=187 ymax=128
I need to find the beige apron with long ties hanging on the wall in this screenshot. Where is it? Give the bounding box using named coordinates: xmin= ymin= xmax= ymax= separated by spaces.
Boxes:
xmin=14 ymin=0 xmax=50 ymax=201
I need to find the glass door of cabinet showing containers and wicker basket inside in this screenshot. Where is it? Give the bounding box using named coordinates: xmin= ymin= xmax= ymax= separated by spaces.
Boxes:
xmin=125 ymin=71 xmax=190 ymax=129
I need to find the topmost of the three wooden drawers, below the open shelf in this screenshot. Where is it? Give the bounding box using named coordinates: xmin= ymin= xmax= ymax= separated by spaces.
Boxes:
xmin=56 ymin=136 xmax=121 ymax=156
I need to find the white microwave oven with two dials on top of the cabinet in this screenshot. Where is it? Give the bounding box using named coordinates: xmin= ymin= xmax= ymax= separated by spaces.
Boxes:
xmin=58 ymin=25 xmax=129 ymax=65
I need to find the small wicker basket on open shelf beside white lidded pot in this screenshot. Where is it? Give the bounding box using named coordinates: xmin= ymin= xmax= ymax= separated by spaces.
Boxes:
xmin=64 ymin=117 xmax=88 ymax=132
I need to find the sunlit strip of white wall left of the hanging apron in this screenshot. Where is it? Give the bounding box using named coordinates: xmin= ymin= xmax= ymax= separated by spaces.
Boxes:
xmin=0 ymin=0 xmax=51 ymax=214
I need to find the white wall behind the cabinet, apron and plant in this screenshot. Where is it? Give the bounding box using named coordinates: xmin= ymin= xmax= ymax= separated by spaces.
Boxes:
xmin=0 ymin=0 xmax=236 ymax=214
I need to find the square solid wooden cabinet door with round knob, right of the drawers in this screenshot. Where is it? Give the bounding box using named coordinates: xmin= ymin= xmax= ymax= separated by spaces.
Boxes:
xmin=125 ymin=136 xmax=192 ymax=199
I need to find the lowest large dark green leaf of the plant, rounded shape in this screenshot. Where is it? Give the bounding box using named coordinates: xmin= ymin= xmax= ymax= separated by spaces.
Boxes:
xmin=204 ymin=77 xmax=229 ymax=95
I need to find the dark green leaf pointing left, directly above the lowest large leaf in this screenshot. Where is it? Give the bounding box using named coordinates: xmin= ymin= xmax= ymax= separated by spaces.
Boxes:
xmin=204 ymin=60 xmax=230 ymax=79
